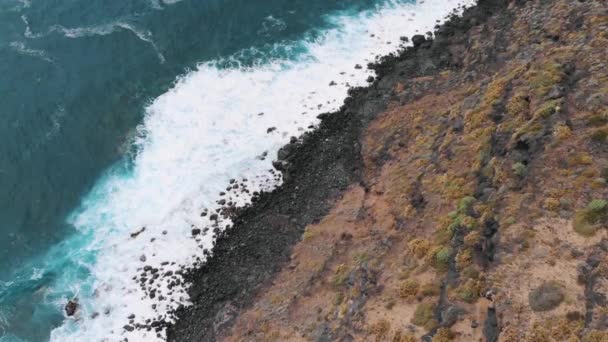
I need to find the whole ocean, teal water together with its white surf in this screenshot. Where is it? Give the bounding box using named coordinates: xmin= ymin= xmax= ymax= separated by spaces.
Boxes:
xmin=0 ymin=0 xmax=474 ymax=342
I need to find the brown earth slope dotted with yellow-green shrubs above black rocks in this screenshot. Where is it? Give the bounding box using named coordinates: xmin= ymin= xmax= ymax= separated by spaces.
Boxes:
xmin=221 ymin=0 xmax=608 ymax=342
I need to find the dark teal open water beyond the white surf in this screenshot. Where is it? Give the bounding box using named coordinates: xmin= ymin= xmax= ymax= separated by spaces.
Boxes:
xmin=0 ymin=0 xmax=402 ymax=341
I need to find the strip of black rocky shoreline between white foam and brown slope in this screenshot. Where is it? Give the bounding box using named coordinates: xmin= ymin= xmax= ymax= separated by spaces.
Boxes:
xmin=168 ymin=0 xmax=508 ymax=341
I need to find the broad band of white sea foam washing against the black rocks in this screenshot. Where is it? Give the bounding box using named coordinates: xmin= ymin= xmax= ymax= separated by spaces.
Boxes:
xmin=51 ymin=0 xmax=473 ymax=342
